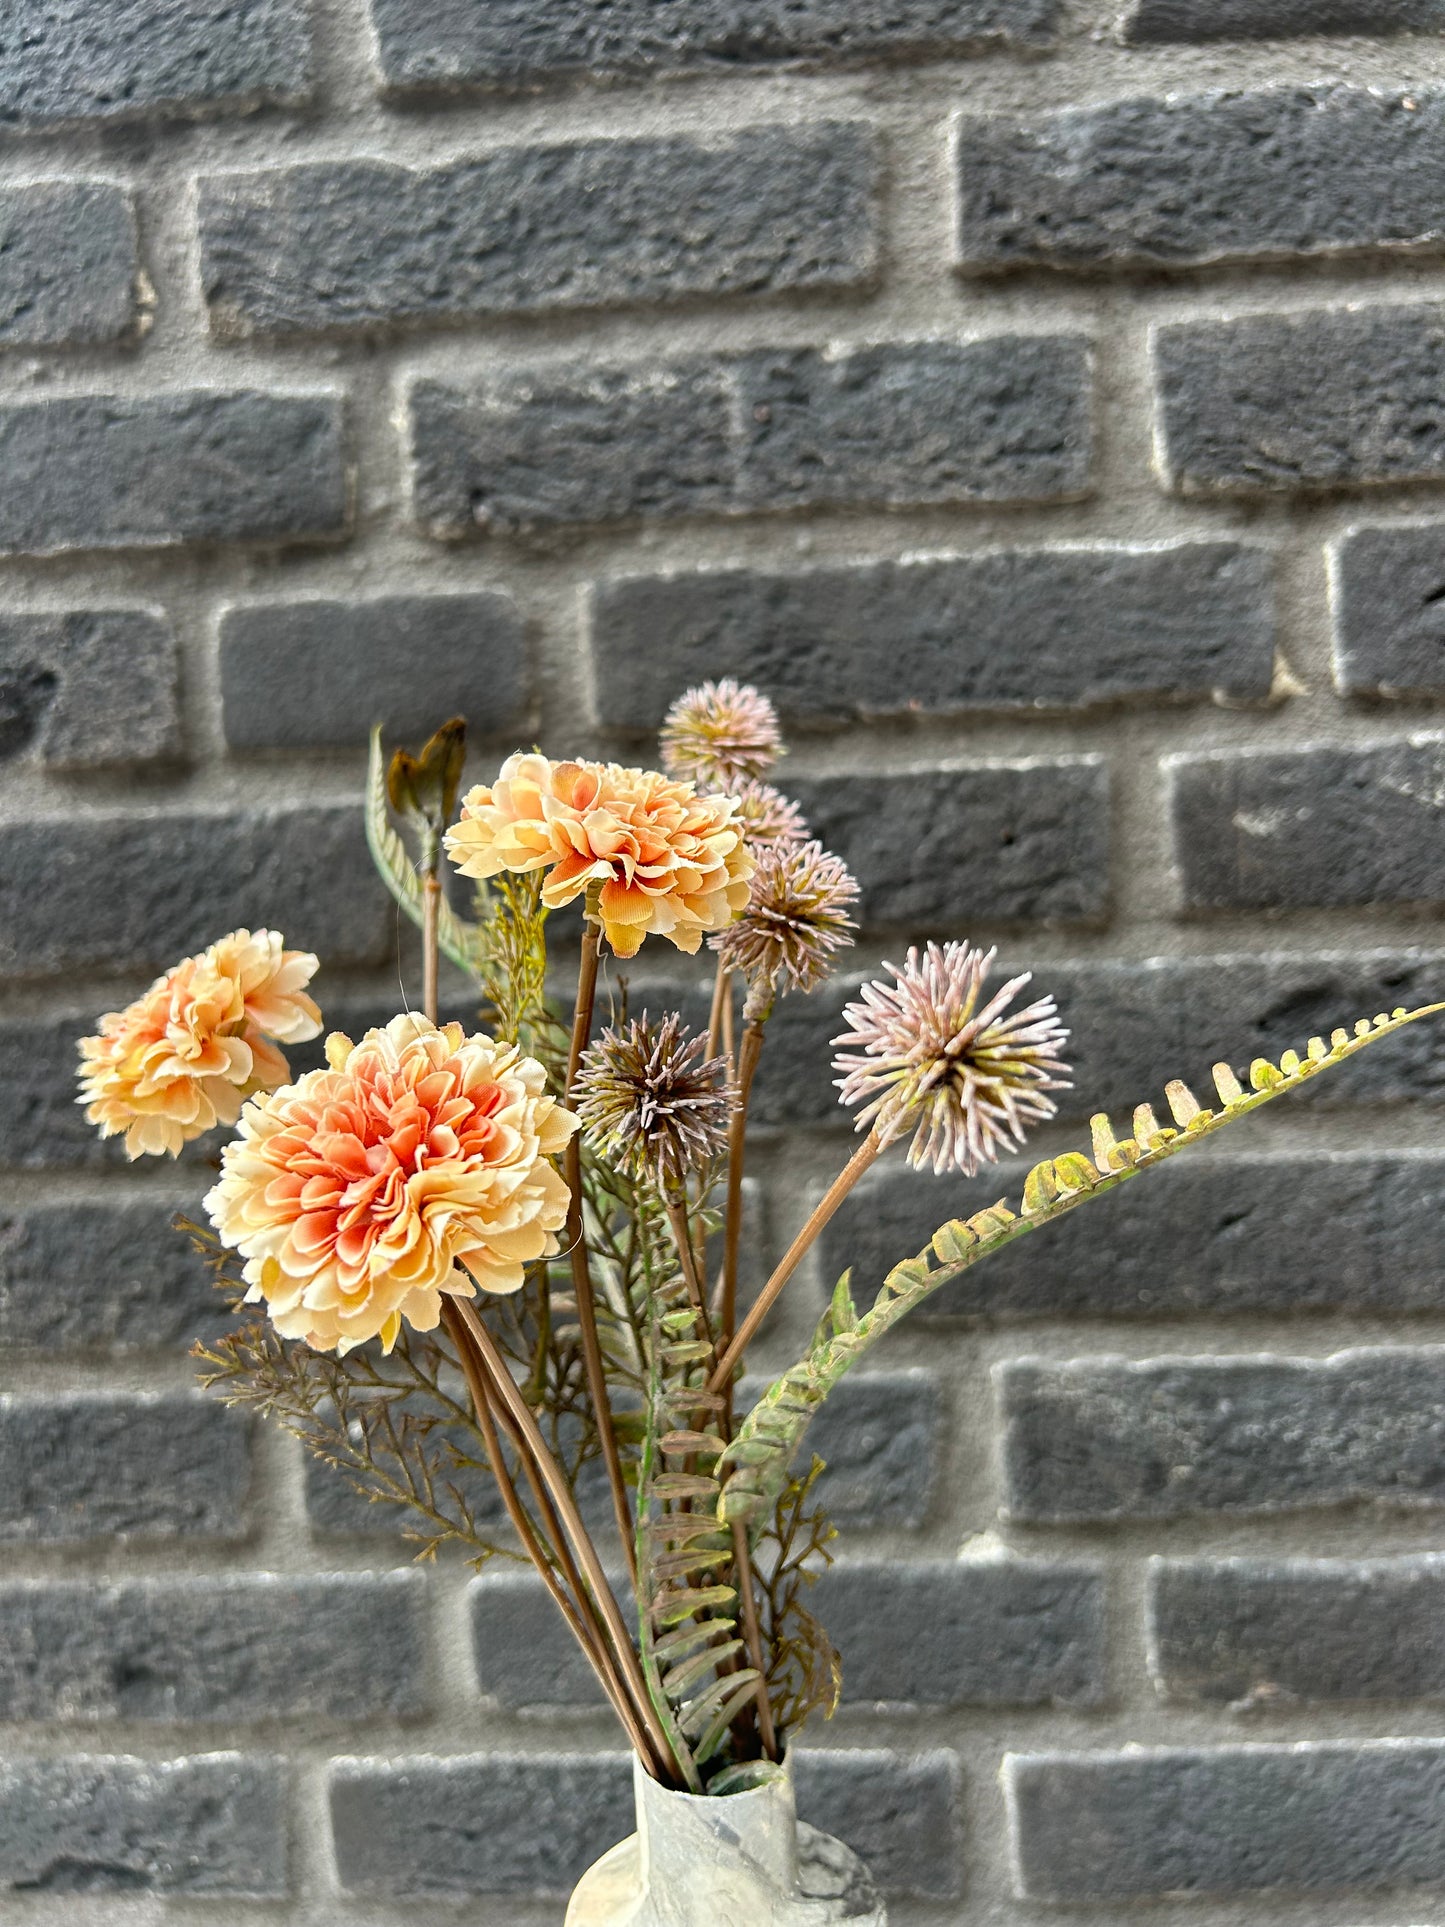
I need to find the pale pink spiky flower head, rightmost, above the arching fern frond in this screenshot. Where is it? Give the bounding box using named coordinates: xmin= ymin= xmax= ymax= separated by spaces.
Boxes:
xmin=832 ymin=942 xmax=1069 ymax=1177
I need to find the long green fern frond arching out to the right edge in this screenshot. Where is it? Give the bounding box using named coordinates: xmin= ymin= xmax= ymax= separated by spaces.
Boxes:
xmin=719 ymin=1004 xmax=1445 ymax=1526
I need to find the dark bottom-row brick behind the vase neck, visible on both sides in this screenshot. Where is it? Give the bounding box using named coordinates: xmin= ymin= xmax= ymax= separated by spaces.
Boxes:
xmin=331 ymin=1750 xmax=959 ymax=1898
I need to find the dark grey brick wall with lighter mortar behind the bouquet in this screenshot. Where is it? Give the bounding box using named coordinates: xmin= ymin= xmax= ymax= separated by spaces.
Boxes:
xmin=0 ymin=0 xmax=1445 ymax=1927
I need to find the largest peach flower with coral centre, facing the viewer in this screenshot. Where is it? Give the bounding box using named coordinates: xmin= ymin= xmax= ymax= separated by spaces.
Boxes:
xmin=206 ymin=1016 xmax=576 ymax=1353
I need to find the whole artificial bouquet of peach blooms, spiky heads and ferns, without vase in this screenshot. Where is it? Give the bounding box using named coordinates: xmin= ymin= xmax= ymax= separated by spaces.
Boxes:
xmin=81 ymin=682 xmax=1439 ymax=1865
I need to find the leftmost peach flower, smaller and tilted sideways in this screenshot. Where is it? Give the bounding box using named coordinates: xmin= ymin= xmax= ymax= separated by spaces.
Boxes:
xmin=79 ymin=931 xmax=322 ymax=1158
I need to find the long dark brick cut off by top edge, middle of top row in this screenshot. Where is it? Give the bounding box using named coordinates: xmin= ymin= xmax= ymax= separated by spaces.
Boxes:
xmin=372 ymin=0 xmax=1060 ymax=92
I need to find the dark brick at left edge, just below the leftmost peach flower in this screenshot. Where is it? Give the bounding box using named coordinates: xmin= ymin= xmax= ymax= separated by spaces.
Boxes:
xmin=0 ymin=1194 xmax=233 ymax=1351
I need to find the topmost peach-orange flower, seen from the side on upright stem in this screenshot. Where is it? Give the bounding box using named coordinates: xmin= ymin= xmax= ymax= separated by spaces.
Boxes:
xmin=447 ymin=755 xmax=753 ymax=958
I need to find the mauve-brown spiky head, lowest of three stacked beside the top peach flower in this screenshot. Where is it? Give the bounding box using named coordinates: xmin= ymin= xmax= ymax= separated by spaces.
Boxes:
xmin=709 ymin=842 xmax=857 ymax=990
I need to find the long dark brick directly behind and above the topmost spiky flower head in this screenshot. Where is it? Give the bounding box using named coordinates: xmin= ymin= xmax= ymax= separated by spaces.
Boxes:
xmin=590 ymin=541 xmax=1274 ymax=724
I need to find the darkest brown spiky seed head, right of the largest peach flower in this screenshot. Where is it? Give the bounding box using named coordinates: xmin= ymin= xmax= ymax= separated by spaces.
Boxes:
xmin=572 ymin=1012 xmax=732 ymax=1195
